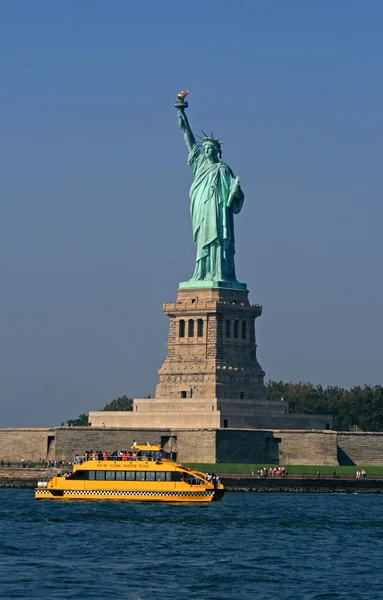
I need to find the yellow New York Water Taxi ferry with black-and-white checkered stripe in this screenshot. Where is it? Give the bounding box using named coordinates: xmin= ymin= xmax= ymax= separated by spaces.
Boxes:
xmin=35 ymin=445 xmax=224 ymax=502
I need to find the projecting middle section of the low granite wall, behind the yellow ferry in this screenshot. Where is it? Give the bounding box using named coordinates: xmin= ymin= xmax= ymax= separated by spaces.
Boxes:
xmin=56 ymin=427 xmax=338 ymax=465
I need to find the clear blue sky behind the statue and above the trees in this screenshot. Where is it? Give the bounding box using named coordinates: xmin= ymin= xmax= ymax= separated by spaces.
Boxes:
xmin=0 ymin=0 xmax=383 ymax=427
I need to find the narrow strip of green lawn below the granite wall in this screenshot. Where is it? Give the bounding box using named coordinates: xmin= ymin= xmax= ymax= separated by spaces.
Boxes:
xmin=187 ymin=463 xmax=383 ymax=476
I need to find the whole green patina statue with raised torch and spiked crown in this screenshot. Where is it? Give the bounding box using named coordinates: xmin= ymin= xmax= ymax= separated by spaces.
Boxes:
xmin=174 ymin=92 xmax=246 ymax=289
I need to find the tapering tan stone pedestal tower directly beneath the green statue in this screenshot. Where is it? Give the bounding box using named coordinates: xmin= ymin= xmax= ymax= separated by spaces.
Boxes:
xmin=156 ymin=288 xmax=268 ymax=404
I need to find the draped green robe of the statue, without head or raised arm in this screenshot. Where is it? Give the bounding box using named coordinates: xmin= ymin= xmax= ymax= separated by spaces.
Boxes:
xmin=188 ymin=145 xmax=244 ymax=281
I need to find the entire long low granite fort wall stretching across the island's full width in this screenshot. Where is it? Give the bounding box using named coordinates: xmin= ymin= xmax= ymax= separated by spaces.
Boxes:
xmin=0 ymin=427 xmax=383 ymax=466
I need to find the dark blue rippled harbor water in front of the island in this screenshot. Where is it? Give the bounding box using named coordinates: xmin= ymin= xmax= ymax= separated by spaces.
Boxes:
xmin=0 ymin=490 xmax=383 ymax=600
